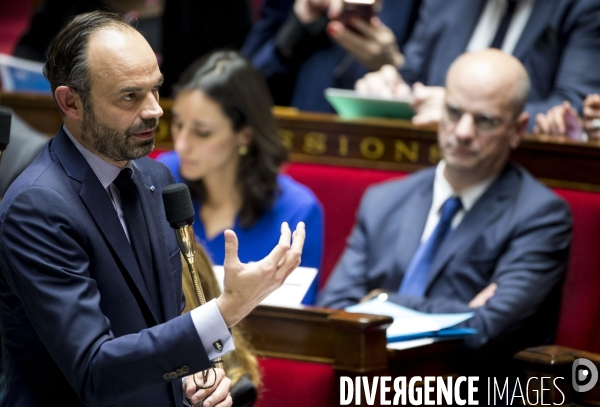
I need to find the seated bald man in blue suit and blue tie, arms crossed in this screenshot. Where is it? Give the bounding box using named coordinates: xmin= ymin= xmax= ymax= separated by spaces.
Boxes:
xmin=319 ymin=50 xmax=571 ymax=372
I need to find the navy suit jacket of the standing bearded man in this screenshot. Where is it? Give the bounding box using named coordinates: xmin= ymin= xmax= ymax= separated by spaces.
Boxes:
xmin=0 ymin=128 xmax=210 ymax=407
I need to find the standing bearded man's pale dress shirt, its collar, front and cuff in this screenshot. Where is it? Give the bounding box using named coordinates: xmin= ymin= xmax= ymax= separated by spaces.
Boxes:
xmin=63 ymin=125 xmax=235 ymax=360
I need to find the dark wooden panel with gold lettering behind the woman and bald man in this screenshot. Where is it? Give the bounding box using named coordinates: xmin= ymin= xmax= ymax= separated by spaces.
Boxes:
xmin=0 ymin=93 xmax=600 ymax=191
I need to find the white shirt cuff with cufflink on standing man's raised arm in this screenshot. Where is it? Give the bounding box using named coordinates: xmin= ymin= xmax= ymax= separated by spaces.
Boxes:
xmin=190 ymin=300 xmax=235 ymax=360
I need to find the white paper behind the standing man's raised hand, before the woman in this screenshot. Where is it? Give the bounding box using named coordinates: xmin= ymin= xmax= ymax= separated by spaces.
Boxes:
xmin=213 ymin=266 xmax=317 ymax=307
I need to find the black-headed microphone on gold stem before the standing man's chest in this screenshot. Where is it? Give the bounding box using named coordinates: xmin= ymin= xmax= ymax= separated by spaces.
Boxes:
xmin=162 ymin=184 xmax=223 ymax=369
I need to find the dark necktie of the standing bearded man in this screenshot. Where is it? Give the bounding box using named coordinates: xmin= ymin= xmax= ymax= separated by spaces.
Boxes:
xmin=113 ymin=168 xmax=161 ymax=315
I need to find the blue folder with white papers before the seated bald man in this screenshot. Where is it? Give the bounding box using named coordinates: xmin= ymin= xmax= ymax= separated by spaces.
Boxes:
xmin=346 ymin=299 xmax=477 ymax=342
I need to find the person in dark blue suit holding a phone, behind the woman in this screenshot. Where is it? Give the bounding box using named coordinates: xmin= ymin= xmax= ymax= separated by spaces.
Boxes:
xmin=242 ymin=0 xmax=421 ymax=112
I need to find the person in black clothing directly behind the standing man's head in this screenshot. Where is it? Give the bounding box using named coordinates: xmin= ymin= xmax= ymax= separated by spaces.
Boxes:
xmin=14 ymin=0 xmax=252 ymax=96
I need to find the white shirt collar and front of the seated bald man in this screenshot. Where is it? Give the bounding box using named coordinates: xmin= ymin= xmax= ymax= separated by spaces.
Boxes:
xmin=421 ymin=160 xmax=499 ymax=243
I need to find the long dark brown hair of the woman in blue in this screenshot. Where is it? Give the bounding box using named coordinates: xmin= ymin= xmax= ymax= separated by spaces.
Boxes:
xmin=175 ymin=51 xmax=288 ymax=227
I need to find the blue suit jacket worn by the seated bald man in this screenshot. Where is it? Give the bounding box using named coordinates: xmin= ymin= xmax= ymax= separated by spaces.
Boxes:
xmin=319 ymin=164 xmax=572 ymax=364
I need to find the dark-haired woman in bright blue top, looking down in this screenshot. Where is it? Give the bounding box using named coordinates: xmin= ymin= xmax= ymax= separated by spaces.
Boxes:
xmin=158 ymin=51 xmax=323 ymax=305
